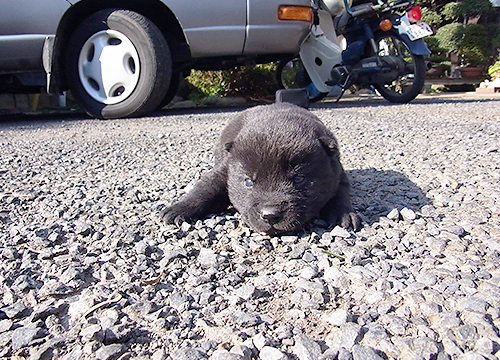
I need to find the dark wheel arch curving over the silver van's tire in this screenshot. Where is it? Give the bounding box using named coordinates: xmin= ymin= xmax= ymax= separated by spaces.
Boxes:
xmin=48 ymin=0 xmax=191 ymax=93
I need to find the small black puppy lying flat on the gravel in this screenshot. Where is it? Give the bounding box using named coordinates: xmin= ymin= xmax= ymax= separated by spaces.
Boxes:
xmin=161 ymin=103 xmax=361 ymax=235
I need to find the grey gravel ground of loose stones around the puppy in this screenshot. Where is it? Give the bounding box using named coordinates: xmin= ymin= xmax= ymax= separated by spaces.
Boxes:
xmin=0 ymin=93 xmax=500 ymax=360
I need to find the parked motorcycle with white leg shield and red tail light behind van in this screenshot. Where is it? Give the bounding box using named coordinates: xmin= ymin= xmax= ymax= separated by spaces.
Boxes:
xmin=276 ymin=0 xmax=432 ymax=103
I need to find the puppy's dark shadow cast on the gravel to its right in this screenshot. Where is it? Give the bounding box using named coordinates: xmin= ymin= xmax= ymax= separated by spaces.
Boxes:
xmin=347 ymin=168 xmax=431 ymax=225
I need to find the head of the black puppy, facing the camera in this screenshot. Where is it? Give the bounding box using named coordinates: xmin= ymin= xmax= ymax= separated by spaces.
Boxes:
xmin=226 ymin=107 xmax=341 ymax=235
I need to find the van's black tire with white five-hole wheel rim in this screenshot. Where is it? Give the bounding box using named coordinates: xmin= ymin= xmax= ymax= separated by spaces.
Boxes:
xmin=66 ymin=9 xmax=172 ymax=119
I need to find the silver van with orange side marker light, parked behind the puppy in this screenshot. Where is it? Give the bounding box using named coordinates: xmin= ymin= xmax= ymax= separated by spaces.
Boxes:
xmin=0 ymin=0 xmax=312 ymax=118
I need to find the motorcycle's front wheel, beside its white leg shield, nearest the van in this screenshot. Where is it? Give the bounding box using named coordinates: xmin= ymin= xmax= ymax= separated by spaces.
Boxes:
xmin=276 ymin=57 xmax=328 ymax=102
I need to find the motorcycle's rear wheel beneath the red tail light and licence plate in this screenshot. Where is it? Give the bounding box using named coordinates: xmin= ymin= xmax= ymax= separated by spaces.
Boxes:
xmin=373 ymin=33 xmax=425 ymax=103
